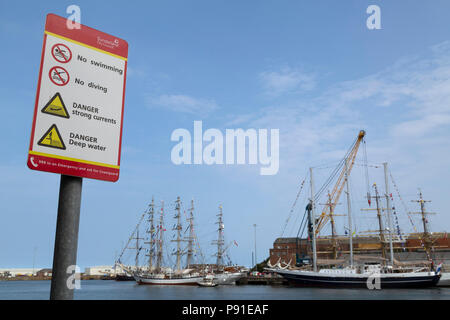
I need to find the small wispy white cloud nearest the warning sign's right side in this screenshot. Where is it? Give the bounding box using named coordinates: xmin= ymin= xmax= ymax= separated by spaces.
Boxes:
xmin=148 ymin=94 xmax=218 ymax=114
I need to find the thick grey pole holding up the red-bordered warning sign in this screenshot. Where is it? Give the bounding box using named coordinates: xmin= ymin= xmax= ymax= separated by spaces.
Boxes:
xmin=50 ymin=175 xmax=83 ymax=300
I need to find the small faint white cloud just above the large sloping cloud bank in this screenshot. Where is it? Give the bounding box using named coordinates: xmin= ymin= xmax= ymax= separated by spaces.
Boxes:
xmin=259 ymin=68 xmax=316 ymax=96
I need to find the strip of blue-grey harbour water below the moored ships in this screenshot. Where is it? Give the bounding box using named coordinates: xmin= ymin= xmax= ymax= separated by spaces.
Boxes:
xmin=0 ymin=280 xmax=450 ymax=300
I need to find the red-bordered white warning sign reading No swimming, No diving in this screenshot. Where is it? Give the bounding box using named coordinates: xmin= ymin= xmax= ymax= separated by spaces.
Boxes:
xmin=27 ymin=14 xmax=128 ymax=181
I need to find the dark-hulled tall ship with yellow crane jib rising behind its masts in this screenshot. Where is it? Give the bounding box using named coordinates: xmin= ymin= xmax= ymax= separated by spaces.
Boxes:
xmin=267 ymin=131 xmax=441 ymax=289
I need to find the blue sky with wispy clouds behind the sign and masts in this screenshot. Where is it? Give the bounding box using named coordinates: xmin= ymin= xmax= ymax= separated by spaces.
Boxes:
xmin=0 ymin=0 xmax=450 ymax=268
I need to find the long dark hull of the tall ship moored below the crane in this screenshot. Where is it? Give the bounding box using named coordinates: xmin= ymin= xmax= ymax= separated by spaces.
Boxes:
xmin=276 ymin=270 xmax=440 ymax=289
